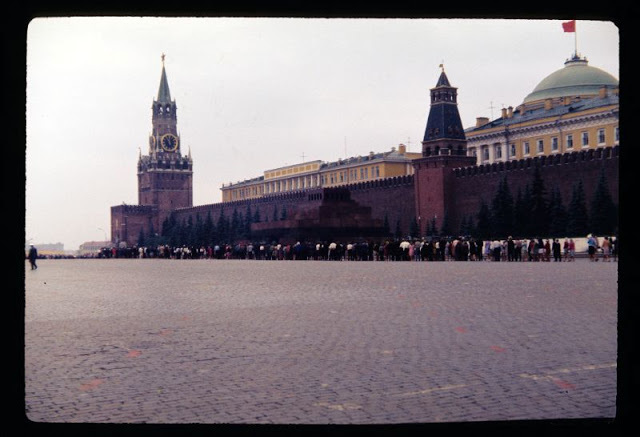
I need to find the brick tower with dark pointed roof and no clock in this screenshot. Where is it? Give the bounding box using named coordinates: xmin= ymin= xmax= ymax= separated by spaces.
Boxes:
xmin=413 ymin=65 xmax=476 ymax=235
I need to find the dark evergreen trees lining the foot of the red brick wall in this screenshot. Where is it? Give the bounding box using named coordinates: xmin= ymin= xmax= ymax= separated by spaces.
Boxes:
xmin=138 ymin=168 xmax=618 ymax=247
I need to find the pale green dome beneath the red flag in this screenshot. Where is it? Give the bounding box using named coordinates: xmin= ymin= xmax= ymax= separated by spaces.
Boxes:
xmin=524 ymin=57 xmax=619 ymax=103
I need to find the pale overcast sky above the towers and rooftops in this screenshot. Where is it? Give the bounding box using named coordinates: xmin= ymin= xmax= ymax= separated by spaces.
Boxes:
xmin=25 ymin=17 xmax=619 ymax=250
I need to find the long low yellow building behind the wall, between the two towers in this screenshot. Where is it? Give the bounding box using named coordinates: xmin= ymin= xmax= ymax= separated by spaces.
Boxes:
xmin=221 ymin=144 xmax=422 ymax=202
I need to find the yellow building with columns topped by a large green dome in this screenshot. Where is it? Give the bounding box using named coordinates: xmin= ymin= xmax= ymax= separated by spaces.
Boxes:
xmin=465 ymin=55 xmax=620 ymax=164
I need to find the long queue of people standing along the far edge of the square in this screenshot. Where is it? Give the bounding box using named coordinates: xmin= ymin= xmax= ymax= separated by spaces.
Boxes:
xmin=92 ymin=234 xmax=618 ymax=262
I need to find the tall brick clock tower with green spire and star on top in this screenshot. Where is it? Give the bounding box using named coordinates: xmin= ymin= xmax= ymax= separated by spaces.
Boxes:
xmin=138 ymin=54 xmax=193 ymax=216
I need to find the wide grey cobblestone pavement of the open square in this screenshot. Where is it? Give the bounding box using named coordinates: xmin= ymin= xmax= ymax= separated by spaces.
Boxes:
xmin=25 ymin=259 xmax=617 ymax=424
